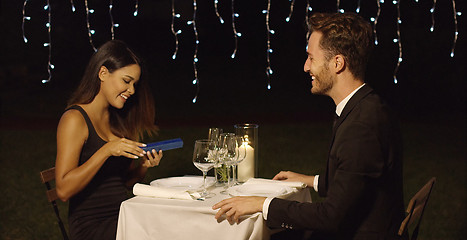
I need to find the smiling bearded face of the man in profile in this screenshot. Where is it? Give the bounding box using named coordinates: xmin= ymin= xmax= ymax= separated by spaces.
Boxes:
xmin=303 ymin=31 xmax=335 ymax=95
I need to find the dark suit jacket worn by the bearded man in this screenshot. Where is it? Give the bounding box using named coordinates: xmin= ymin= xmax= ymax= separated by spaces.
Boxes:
xmin=267 ymin=85 xmax=404 ymax=239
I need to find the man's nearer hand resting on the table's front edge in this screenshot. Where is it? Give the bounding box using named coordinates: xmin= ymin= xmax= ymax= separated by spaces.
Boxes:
xmin=212 ymin=197 xmax=266 ymax=224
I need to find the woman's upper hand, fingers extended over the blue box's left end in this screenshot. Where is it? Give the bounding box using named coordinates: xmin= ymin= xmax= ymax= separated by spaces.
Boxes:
xmin=104 ymin=138 xmax=146 ymax=159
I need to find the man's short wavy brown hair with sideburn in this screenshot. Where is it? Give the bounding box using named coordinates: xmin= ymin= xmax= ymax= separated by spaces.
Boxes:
xmin=308 ymin=13 xmax=374 ymax=81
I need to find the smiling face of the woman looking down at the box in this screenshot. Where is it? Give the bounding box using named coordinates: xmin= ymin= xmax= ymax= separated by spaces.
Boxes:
xmin=99 ymin=64 xmax=141 ymax=109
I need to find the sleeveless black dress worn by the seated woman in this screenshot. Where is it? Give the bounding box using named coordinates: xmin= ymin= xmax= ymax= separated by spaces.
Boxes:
xmin=68 ymin=105 xmax=132 ymax=240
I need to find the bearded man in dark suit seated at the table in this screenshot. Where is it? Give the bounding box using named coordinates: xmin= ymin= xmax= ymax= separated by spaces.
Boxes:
xmin=213 ymin=13 xmax=404 ymax=239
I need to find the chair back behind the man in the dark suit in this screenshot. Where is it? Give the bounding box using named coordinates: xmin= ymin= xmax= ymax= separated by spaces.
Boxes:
xmin=399 ymin=177 xmax=436 ymax=240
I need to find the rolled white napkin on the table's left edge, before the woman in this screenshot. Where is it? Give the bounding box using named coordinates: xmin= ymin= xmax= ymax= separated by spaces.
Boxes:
xmin=133 ymin=183 xmax=201 ymax=200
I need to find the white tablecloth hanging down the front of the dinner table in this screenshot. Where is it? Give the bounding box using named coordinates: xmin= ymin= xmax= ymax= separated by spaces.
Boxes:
xmin=117 ymin=179 xmax=311 ymax=240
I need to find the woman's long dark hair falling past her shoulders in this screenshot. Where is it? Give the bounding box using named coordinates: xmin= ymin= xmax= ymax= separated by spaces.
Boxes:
xmin=68 ymin=40 xmax=157 ymax=140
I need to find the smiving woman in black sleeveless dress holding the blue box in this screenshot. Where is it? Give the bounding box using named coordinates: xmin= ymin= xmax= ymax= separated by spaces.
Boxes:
xmin=55 ymin=40 xmax=162 ymax=239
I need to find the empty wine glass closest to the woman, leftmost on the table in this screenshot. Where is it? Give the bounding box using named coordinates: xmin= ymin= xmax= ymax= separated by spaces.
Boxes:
xmin=193 ymin=139 xmax=216 ymax=199
